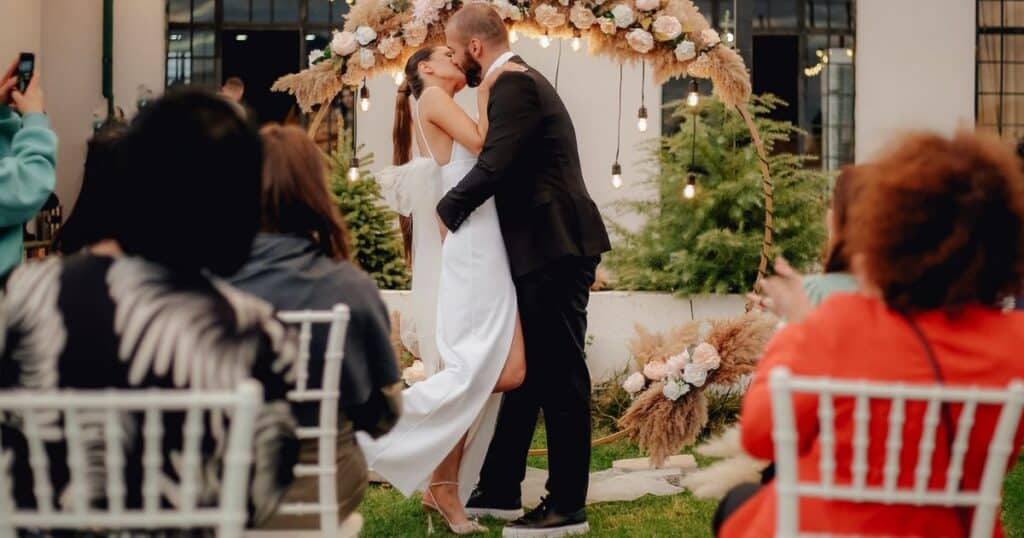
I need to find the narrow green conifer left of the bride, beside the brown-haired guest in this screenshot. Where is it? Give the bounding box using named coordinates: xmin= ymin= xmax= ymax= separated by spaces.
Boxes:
xmin=331 ymin=130 xmax=410 ymax=289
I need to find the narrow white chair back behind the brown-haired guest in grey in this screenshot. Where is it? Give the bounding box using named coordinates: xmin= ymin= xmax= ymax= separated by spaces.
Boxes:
xmin=278 ymin=304 xmax=349 ymax=538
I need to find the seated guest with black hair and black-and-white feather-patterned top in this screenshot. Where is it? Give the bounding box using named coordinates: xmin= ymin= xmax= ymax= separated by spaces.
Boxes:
xmin=0 ymin=90 xmax=298 ymax=523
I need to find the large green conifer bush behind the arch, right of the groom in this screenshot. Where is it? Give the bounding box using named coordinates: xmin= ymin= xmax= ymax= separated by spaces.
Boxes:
xmin=608 ymin=95 xmax=828 ymax=294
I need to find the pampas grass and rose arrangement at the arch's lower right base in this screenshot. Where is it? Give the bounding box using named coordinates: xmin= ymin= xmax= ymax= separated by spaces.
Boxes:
xmin=618 ymin=313 xmax=776 ymax=466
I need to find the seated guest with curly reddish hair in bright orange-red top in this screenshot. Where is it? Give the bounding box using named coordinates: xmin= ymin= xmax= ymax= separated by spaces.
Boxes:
xmin=716 ymin=132 xmax=1024 ymax=537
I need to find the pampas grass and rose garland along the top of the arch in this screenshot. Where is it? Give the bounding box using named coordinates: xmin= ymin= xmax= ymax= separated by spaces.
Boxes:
xmin=272 ymin=0 xmax=751 ymax=113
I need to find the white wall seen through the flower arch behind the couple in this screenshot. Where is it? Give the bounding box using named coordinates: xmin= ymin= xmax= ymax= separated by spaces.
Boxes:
xmin=358 ymin=38 xmax=662 ymax=225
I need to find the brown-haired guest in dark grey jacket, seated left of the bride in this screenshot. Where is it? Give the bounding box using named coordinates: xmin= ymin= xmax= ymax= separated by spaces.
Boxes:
xmin=231 ymin=125 xmax=401 ymax=529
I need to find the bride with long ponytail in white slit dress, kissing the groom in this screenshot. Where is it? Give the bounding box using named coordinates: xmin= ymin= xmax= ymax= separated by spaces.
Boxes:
xmin=359 ymin=46 xmax=526 ymax=534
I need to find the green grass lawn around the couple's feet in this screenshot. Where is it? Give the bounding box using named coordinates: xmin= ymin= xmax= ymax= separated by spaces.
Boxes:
xmin=359 ymin=427 xmax=1024 ymax=538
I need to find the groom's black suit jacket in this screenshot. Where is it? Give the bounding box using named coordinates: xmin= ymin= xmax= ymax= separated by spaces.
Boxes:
xmin=437 ymin=56 xmax=611 ymax=277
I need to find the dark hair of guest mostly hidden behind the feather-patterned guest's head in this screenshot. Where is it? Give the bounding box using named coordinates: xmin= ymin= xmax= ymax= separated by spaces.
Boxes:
xmin=53 ymin=120 xmax=127 ymax=255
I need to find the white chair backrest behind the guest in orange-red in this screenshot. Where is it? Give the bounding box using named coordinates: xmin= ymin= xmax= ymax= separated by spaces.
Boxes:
xmin=769 ymin=367 xmax=1024 ymax=538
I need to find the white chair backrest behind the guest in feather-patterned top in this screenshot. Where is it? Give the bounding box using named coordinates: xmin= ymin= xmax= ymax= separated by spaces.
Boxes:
xmin=0 ymin=380 xmax=263 ymax=538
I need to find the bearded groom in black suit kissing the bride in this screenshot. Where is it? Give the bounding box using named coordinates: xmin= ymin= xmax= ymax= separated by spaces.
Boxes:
xmin=437 ymin=4 xmax=610 ymax=536
